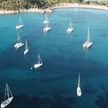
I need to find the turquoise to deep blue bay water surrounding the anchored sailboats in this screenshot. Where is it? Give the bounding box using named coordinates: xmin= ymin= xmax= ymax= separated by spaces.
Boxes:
xmin=0 ymin=8 xmax=108 ymax=108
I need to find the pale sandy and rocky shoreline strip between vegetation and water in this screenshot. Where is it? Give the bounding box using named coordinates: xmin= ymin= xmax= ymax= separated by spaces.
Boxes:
xmin=0 ymin=3 xmax=108 ymax=14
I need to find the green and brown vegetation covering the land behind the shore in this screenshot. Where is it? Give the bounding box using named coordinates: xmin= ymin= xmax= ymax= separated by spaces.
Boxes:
xmin=0 ymin=0 xmax=108 ymax=10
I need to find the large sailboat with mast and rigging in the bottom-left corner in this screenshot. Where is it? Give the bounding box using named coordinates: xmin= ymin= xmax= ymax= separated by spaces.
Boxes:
xmin=1 ymin=83 xmax=13 ymax=108
